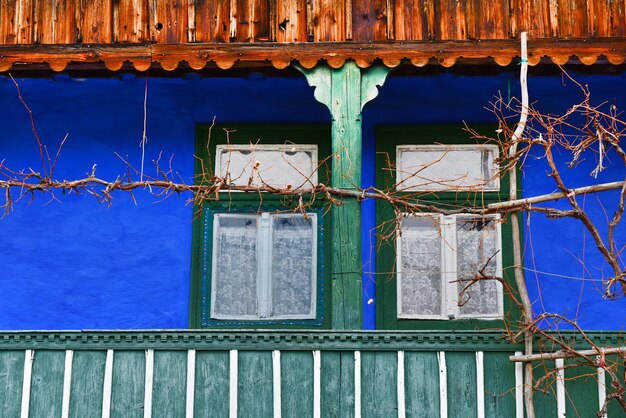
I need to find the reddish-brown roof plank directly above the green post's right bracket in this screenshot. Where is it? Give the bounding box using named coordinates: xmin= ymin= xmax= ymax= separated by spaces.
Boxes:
xmin=352 ymin=0 xmax=388 ymax=41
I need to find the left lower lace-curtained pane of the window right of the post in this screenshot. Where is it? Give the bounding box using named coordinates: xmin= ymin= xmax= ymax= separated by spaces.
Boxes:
xmin=398 ymin=216 xmax=442 ymax=316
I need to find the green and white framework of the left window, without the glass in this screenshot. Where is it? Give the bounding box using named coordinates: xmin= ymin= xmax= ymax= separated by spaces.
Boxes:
xmin=189 ymin=123 xmax=331 ymax=328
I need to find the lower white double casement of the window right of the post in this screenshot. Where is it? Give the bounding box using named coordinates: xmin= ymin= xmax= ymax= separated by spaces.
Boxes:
xmin=396 ymin=213 xmax=502 ymax=319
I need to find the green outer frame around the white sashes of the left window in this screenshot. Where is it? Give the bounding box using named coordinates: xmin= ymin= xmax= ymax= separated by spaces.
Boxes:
xmin=189 ymin=123 xmax=331 ymax=329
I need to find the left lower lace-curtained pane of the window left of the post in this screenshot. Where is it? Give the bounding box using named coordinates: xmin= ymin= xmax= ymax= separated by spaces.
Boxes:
xmin=212 ymin=215 xmax=257 ymax=318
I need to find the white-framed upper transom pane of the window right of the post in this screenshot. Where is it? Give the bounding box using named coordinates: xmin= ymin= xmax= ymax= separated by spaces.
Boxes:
xmin=396 ymin=144 xmax=500 ymax=191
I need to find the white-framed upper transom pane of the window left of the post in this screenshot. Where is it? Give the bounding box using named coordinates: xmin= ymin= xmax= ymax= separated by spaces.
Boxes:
xmin=215 ymin=144 xmax=317 ymax=189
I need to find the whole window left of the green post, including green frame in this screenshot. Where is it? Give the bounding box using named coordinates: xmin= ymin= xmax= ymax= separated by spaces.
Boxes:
xmin=190 ymin=125 xmax=330 ymax=328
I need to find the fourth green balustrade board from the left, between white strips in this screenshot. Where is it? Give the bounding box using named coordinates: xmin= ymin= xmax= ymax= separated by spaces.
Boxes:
xmin=111 ymin=350 xmax=146 ymax=418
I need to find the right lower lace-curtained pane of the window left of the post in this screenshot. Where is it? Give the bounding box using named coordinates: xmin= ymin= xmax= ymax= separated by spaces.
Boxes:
xmin=271 ymin=214 xmax=317 ymax=317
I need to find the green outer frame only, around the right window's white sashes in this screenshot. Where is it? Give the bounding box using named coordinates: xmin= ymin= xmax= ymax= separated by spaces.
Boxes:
xmin=375 ymin=123 xmax=522 ymax=330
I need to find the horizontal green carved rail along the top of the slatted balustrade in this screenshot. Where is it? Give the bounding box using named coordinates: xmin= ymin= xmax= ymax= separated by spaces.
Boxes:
xmin=0 ymin=329 xmax=626 ymax=351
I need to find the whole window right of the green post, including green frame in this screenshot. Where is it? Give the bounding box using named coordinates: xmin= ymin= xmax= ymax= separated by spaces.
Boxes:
xmin=376 ymin=126 xmax=512 ymax=329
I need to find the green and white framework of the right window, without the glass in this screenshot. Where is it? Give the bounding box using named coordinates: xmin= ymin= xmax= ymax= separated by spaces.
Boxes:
xmin=375 ymin=125 xmax=520 ymax=330
